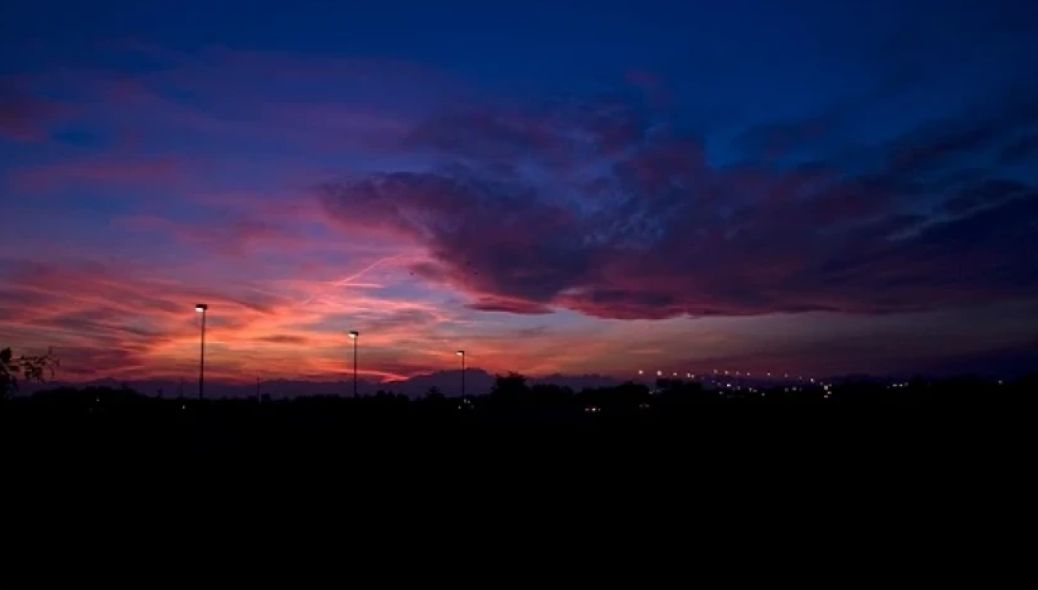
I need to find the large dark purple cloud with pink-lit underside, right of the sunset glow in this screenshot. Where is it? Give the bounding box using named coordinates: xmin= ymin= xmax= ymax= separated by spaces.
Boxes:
xmin=323 ymin=92 xmax=1038 ymax=318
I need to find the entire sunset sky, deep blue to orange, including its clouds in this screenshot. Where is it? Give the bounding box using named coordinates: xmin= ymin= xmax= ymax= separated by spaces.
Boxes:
xmin=0 ymin=0 xmax=1038 ymax=381
